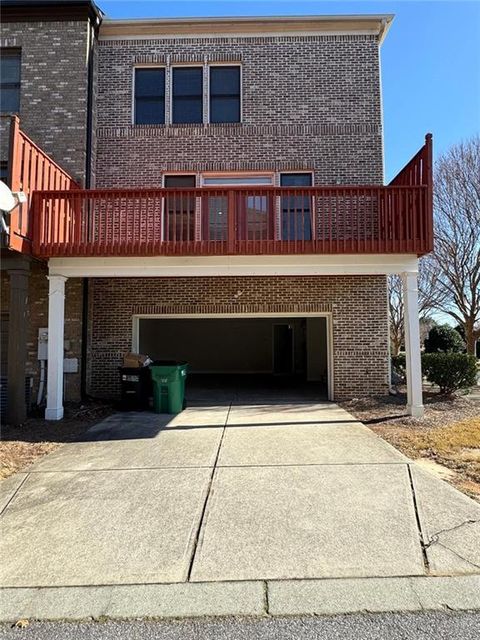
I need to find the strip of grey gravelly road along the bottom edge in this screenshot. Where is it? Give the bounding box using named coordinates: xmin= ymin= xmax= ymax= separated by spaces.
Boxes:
xmin=0 ymin=612 xmax=480 ymax=640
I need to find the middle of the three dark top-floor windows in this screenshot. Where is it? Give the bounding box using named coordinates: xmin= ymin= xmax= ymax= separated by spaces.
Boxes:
xmin=172 ymin=67 xmax=203 ymax=124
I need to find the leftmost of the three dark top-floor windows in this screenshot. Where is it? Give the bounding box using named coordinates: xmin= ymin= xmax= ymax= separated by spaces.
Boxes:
xmin=135 ymin=67 xmax=165 ymax=124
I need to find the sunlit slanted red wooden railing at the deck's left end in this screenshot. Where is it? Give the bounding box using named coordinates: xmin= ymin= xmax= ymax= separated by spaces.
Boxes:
xmin=8 ymin=116 xmax=80 ymax=253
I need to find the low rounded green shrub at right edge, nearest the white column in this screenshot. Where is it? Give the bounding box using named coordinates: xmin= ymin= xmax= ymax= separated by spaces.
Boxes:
xmin=422 ymin=353 xmax=477 ymax=395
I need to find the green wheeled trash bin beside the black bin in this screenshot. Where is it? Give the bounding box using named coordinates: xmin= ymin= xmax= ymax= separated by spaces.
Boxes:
xmin=150 ymin=360 xmax=188 ymax=413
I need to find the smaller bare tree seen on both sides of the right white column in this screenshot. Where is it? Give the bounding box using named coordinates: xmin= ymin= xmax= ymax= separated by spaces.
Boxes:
xmin=388 ymin=256 xmax=443 ymax=355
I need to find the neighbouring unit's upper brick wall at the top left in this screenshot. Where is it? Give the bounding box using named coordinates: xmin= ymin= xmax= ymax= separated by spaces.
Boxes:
xmin=0 ymin=20 xmax=94 ymax=182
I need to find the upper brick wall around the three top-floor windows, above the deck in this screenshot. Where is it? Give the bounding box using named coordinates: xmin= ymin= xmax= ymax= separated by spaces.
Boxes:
xmin=97 ymin=34 xmax=383 ymax=187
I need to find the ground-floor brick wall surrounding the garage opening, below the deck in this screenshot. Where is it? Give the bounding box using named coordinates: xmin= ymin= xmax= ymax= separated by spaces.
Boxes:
xmin=88 ymin=276 xmax=388 ymax=400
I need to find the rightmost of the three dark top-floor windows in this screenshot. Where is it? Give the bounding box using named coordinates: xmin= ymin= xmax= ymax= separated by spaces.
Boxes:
xmin=210 ymin=65 xmax=240 ymax=122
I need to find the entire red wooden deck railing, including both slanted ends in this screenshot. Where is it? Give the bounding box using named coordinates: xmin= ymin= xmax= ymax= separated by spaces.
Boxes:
xmin=4 ymin=116 xmax=433 ymax=258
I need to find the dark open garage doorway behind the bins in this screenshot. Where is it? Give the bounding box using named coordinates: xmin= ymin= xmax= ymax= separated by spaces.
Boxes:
xmin=136 ymin=317 xmax=329 ymax=399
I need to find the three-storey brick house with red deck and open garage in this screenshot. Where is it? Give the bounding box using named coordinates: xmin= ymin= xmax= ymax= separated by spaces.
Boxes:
xmin=2 ymin=2 xmax=432 ymax=419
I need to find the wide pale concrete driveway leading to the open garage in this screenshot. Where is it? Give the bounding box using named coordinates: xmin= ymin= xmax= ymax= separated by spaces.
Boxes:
xmin=0 ymin=397 xmax=480 ymax=613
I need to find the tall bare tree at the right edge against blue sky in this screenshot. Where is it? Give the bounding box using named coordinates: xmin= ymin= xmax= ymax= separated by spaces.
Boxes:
xmin=433 ymin=136 xmax=480 ymax=354
